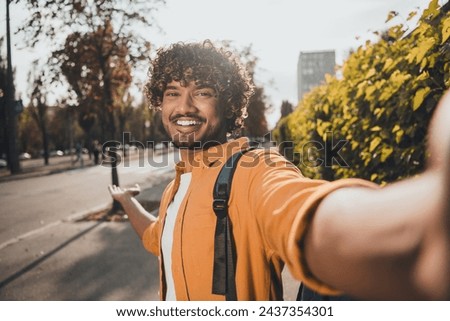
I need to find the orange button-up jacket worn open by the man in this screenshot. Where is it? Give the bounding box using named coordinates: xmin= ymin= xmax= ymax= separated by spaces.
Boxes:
xmin=142 ymin=138 xmax=370 ymax=301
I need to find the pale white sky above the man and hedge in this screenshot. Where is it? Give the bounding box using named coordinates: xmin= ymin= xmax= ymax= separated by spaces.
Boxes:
xmin=0 ymin=0 xmax=442 ymax=125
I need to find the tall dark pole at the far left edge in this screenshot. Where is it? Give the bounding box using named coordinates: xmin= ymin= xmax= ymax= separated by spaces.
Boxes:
xmin=5 ymin=0 xmax=20 ymax=174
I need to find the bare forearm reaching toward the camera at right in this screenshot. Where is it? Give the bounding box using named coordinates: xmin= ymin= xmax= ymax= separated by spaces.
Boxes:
xmin=305 ymin=93 xmax=450 ymax=300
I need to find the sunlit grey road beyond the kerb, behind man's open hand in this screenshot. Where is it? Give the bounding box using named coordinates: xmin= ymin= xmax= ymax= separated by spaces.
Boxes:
xmin=0 ymin=150 xmax=174 ymax=245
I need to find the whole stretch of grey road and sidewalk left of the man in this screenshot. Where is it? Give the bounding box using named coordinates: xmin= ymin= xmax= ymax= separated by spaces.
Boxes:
xmin=0 ymin=150 xmax=173 ymax=301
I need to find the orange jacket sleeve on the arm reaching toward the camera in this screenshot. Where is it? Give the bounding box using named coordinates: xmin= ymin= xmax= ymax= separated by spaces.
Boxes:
xmin=244 ymin=151 xmax=375 ymax=295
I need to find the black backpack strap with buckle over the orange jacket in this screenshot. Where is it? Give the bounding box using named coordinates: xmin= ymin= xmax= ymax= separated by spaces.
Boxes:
xmin=212 ymin=148 xmax=254 ymax=301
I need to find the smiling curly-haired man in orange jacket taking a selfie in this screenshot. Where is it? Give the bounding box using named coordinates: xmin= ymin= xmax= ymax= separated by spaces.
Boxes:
xmin=110 ymin=41 xmax=450 ymax=300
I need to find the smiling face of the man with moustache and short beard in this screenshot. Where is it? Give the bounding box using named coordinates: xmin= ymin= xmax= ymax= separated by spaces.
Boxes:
xmin=161 ymin=81 xmax=226 ymax=148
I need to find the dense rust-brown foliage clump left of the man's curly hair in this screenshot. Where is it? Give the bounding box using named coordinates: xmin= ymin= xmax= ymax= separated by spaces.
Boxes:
xmin=53 ymin=23 xmax=132 ymax=146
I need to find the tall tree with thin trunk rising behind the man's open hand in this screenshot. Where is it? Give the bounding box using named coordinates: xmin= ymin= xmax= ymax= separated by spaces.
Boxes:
xmin=16 ymin=0 xmax=164 ymax=210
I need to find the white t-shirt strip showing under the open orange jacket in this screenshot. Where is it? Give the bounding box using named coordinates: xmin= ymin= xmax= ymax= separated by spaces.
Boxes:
xmin=161 ymin=173 xmax=192 ymax=301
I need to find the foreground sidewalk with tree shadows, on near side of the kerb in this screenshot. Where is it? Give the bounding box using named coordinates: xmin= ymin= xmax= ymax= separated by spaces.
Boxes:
xmin=0 ymin=222 xmax=159 ymax=301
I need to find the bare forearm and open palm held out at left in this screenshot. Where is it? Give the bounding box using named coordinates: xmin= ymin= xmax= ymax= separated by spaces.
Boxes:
xmin=108 ymin=184 xmax=156 ymax=239
